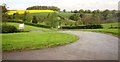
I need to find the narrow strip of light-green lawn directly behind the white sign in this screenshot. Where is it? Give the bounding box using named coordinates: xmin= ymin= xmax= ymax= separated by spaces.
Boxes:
xmin=4 ymin=22 xmax=49 ymax=31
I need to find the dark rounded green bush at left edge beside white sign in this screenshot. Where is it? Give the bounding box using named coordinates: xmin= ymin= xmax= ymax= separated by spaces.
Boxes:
xmin=2 ymin=24 xmax=19 ymax=33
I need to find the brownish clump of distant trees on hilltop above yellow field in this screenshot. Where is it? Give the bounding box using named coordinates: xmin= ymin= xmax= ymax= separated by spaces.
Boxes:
xmin=26 ymin=6 xmax=60 ymax=11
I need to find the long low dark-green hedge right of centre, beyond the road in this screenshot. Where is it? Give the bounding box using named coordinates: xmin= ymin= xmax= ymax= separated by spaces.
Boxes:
xmin=62 ymin=25 xmax=103 ymax=29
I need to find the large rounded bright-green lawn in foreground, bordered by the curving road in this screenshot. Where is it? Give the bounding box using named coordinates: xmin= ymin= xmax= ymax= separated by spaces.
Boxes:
xmin=2 ymin=32 xmax=79 ymax=51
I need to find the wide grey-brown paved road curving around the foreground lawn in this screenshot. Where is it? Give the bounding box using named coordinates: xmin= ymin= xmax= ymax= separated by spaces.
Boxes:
xmin=3 ymin=31 xmax=118 ymax=60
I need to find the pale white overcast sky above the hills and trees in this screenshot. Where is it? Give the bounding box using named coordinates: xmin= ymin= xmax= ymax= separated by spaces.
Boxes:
xmin=0 ymin=0 xmax=120 ymax=10
